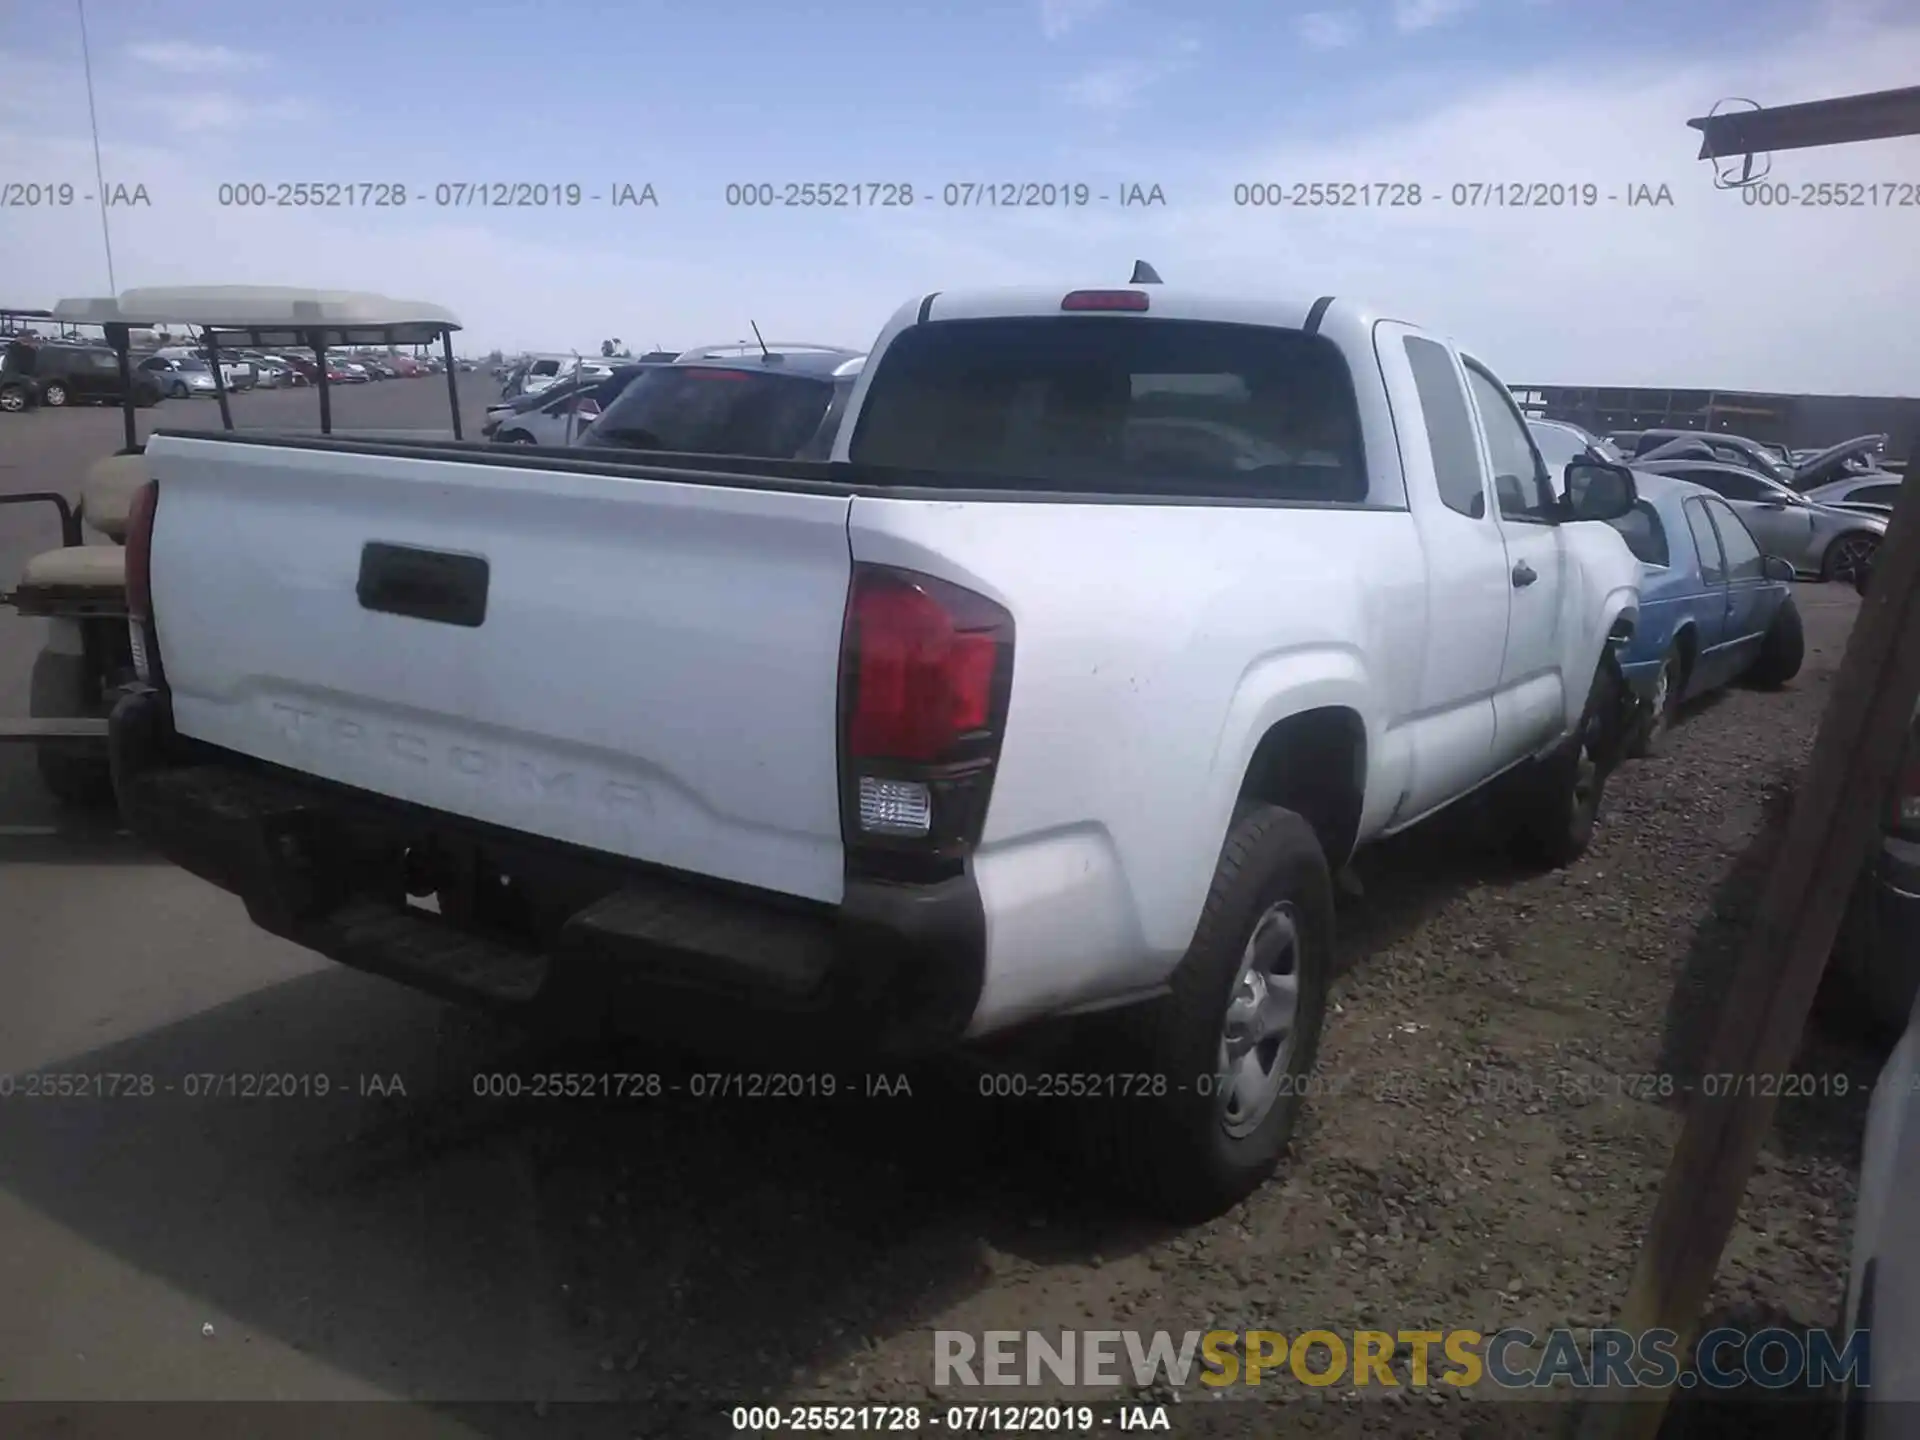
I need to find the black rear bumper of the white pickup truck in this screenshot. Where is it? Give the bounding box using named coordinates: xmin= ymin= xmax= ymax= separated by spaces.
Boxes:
xmin=109 ymin=691 xmax=987 ymax=1056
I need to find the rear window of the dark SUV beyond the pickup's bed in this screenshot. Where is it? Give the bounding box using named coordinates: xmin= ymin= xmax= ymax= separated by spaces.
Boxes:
xmin=584 ymin=365 xmax=833 ymax=459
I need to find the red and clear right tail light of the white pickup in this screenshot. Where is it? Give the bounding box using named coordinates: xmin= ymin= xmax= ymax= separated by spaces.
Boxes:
xmin=841 ymin=564 xmax=1014 ymax=868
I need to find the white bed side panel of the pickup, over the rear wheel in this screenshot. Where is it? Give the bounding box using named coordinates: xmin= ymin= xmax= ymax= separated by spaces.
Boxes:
xmin=851 ymin=497 xmax=1425 ymax=1029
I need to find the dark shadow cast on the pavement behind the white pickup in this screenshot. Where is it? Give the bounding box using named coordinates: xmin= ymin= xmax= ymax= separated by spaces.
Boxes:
xmin=0 ymin=970 xmax=1156 ymax=1434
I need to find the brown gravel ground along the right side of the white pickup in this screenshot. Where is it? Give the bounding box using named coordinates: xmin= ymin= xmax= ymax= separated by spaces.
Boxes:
xmin=679 ymin=586 xmax=1878 ymax=1434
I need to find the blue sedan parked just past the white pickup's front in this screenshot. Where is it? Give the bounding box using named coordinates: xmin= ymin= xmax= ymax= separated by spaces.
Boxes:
xmin=1613 ymin=470 xmax=1807 ymax=755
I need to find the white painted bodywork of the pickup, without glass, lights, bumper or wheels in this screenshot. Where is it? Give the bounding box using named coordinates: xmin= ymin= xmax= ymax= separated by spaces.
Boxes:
xmin=135 ymin=286 xmax=1640 ymax=1035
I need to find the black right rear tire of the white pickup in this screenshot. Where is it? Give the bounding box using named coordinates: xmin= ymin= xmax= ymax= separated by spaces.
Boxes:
xmin=1091 ymin=803 xmax=1334 ymax=1221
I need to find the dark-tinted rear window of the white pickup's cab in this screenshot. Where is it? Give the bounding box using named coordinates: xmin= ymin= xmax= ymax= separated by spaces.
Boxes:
xmin=849 ymin=315 xmax=1367 ymax=503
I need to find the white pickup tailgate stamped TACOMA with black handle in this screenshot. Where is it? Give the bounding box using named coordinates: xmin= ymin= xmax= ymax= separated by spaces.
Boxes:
xmin=148 ymin=436 xmax=851 ymax=902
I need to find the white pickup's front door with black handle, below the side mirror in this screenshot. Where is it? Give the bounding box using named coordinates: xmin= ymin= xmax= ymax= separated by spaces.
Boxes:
xmin=1463 ymin=357 xmax=1567 ymax=760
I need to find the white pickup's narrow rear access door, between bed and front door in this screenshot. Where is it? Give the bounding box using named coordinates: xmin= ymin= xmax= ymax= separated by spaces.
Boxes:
xmin=1375 ymin=324 xmax=1511 ymax=824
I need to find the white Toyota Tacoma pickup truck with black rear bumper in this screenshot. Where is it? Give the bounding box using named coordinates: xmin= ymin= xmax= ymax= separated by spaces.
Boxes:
xmin=111 ymin=284 xmax=1640 ymax=1213
